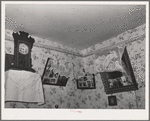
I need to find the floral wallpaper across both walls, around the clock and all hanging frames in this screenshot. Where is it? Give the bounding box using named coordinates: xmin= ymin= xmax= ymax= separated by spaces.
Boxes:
xmin=5 ymin=25 xmax=145 ymax=109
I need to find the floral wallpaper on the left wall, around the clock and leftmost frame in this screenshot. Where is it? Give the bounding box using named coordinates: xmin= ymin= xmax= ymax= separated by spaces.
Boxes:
xmin=5 ymin=32 xmax=86 ymax=108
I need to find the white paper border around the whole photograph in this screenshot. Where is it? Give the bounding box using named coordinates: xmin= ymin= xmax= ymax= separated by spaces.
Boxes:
xmin=1 ymin=1 xmax=149 ymax=120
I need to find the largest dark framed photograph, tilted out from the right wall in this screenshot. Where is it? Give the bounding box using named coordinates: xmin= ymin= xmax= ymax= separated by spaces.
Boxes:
xmin=100 ymin=48 xmax=138 ymax=94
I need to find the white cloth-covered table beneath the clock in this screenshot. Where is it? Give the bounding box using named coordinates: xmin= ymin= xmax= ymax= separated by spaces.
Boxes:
xmin=5 ymin=70 xmax=44 ymax=105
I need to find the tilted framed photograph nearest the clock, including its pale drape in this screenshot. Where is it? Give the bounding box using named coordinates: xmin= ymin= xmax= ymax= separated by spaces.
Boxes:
xmin=42 ymin=58 xmax=70 ymax=86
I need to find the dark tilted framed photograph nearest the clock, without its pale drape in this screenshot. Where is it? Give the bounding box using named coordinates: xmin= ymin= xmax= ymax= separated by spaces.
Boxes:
xmin=42 ymin=58 xmax=69 ymax=86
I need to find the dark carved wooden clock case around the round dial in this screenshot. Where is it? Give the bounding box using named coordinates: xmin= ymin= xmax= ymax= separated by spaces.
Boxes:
xmin=10 ymin=31 xmax=35 ymax=72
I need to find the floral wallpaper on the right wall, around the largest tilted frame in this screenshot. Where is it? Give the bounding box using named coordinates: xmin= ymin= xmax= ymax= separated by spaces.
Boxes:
xmin=83 ymin=24 xmax=146 ymax=109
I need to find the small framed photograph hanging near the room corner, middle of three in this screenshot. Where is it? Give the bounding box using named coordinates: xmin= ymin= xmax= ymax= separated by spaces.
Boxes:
xmin=77 ymin=74 xmax=96 ymax=89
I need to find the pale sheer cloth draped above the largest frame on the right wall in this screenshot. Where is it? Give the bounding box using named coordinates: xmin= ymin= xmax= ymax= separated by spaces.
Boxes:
xmin=94 ymin=47 xmax=123 ymax=72
